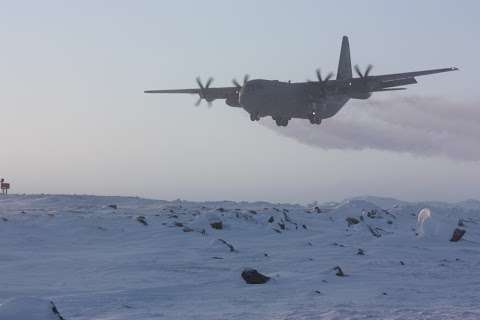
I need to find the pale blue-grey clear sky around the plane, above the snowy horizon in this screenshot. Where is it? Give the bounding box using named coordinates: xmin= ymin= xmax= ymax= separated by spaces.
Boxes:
xmin=0 ymin=0 xmax=480 ymax=202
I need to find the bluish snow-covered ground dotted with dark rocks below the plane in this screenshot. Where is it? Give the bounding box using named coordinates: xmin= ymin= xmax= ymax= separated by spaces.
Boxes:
xmin=0 ymin=195 xmax=480 ymax=320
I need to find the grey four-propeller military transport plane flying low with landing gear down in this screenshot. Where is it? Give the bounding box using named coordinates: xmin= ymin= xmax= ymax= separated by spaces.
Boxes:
xmin=145 ymin=36 xmax=458 ymax=126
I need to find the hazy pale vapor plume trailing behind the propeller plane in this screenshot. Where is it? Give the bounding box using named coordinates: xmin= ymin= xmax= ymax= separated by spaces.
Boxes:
xmin=262 ymin=96 xmax=480 ymax=161
